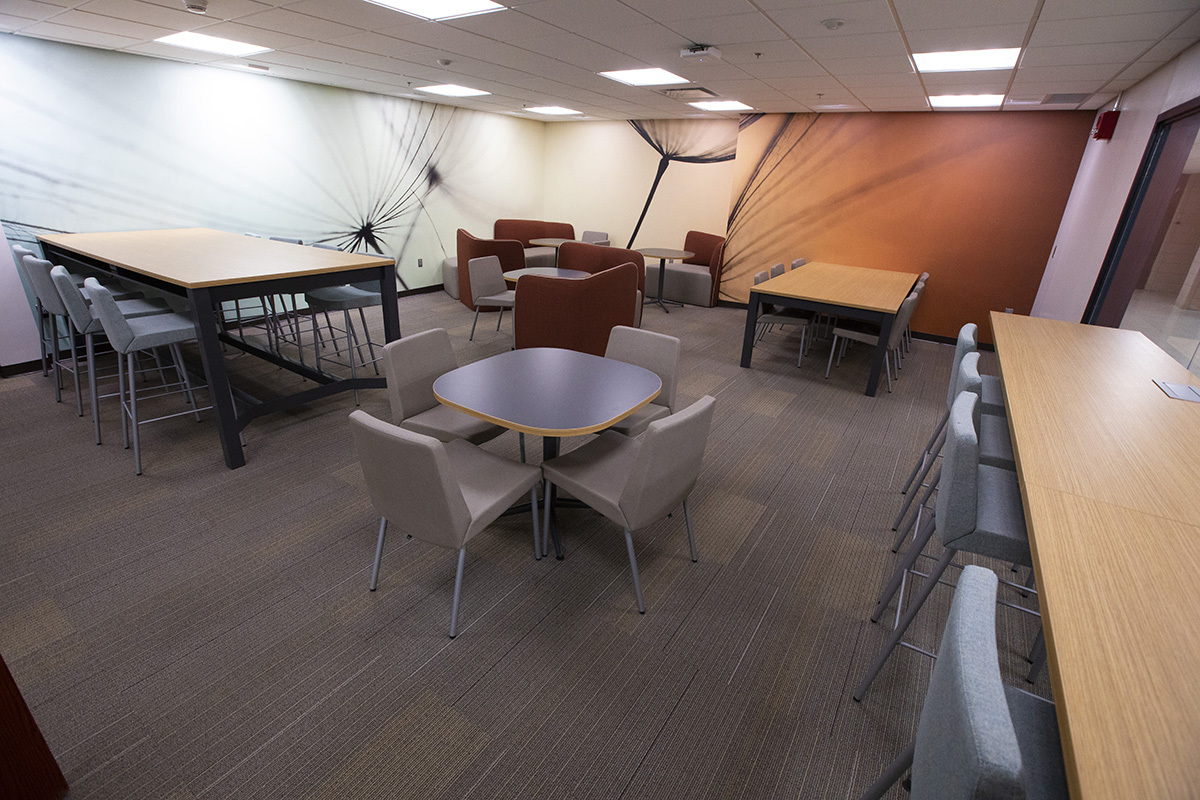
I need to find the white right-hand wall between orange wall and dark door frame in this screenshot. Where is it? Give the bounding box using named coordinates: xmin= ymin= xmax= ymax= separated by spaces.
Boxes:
xmin=1031 ymin=46 xmax=1200 ymax=323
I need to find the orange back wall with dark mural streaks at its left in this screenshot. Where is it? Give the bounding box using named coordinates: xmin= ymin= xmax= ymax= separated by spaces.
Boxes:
xmin=721 ymin=112 xmax=1093 ymax=337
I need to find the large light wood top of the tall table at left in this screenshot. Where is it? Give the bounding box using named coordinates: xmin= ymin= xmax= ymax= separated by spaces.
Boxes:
xmin=38 ymin=228 xmax=391 ymax=289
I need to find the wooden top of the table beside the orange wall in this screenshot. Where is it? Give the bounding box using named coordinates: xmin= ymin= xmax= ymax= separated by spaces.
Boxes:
xmin=750 ymin=261 xmax=919 ymax=314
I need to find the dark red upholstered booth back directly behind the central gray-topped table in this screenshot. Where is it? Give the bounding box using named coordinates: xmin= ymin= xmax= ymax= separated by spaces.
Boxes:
xmin=512 ymin=264 xmax=638 ymax=355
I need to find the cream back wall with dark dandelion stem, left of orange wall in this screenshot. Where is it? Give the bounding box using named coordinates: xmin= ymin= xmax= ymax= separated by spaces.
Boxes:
xmin=542 ymin=120 xmax=738 ymax=248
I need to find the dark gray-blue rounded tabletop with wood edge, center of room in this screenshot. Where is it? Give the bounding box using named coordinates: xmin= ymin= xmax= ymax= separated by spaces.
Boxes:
xmin=433 ymin=348 xmax=662 ymax=437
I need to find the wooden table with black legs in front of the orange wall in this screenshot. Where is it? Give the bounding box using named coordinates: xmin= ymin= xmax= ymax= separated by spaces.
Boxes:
xmin=742 ymin=261 xmax=918 ymax=397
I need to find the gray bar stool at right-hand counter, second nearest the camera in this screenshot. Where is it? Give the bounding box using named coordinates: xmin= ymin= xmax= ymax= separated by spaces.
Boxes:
xmin=854 ymin=392 xmax=1037 ymax=700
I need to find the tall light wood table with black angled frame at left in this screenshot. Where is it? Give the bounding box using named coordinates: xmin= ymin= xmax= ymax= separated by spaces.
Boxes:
xmin=38 ymin=228 xmax=400 ymax=469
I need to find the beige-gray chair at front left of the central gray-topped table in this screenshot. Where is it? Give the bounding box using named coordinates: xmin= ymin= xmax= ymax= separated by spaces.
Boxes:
xmin=350 ymin=411 xmax=541 ymax=639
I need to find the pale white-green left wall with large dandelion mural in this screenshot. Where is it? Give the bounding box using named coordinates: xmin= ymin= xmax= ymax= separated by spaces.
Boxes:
xmin=0 ymin=36 xmax=542 ymax=289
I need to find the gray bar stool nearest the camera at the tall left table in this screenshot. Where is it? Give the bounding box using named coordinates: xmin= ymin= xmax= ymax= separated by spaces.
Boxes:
xmin=84 ymin=278 xmax=205 ymax=475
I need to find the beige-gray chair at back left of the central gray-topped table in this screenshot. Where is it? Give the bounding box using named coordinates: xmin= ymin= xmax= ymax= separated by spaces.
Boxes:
xmin=383 ymin=327 xmax=504 ymax=445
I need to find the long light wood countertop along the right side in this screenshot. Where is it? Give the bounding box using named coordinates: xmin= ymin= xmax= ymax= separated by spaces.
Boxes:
xmin=991 ymin=312 xmax=1200 ymax=800
